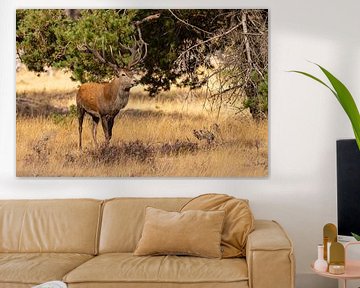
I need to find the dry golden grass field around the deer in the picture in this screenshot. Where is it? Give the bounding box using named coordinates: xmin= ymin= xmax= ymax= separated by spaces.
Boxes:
xmin=16 ymin=70 xmax=268 ymax=177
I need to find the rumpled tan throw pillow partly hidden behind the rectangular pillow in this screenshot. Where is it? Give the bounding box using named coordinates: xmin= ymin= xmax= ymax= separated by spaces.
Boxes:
xmin=181 ymin=194 xmax=254 ymax=258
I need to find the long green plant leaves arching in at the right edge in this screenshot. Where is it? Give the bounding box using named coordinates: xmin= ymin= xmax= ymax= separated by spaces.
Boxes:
xmin=289 ymin=63 xmax=360 ymax=150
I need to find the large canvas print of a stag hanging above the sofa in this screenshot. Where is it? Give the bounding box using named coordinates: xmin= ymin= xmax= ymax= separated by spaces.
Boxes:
xmin=16 ymin=9 xmax=268 ymax=177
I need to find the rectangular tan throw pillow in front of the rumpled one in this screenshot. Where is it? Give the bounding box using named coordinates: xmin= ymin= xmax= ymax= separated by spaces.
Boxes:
xmin=134 ymin=207 xmax=225 ymax=258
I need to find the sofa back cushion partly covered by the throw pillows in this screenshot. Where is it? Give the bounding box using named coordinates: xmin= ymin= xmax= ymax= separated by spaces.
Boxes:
xmin=99 ymin=198 xmax=190 ymax=254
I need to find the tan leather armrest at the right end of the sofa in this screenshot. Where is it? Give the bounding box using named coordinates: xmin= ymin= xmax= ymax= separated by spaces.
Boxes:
xmin=246 ymin=220 xmax=295 ymax=288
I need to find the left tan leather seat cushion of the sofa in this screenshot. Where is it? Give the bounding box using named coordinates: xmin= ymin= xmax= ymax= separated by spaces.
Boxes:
xmin=0 ymin=253 xmax=93 ymax=285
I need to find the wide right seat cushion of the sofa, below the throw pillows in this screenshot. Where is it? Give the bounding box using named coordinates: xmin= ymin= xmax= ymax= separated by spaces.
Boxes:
xmin=64 ymin=253 xmax=248 ymax=284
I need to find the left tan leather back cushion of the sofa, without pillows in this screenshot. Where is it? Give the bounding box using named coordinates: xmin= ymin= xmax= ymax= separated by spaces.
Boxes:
xmin=0 ymin=199 xmax=103 ymax=254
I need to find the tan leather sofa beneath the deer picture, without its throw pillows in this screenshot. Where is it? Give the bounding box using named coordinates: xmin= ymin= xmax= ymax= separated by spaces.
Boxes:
xmin=0 ymin=198 xmax=294 ymax=288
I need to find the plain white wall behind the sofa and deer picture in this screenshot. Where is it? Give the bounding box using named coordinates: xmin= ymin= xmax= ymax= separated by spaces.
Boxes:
xmin=0 ymin=0 xmax=360 ymax=288
